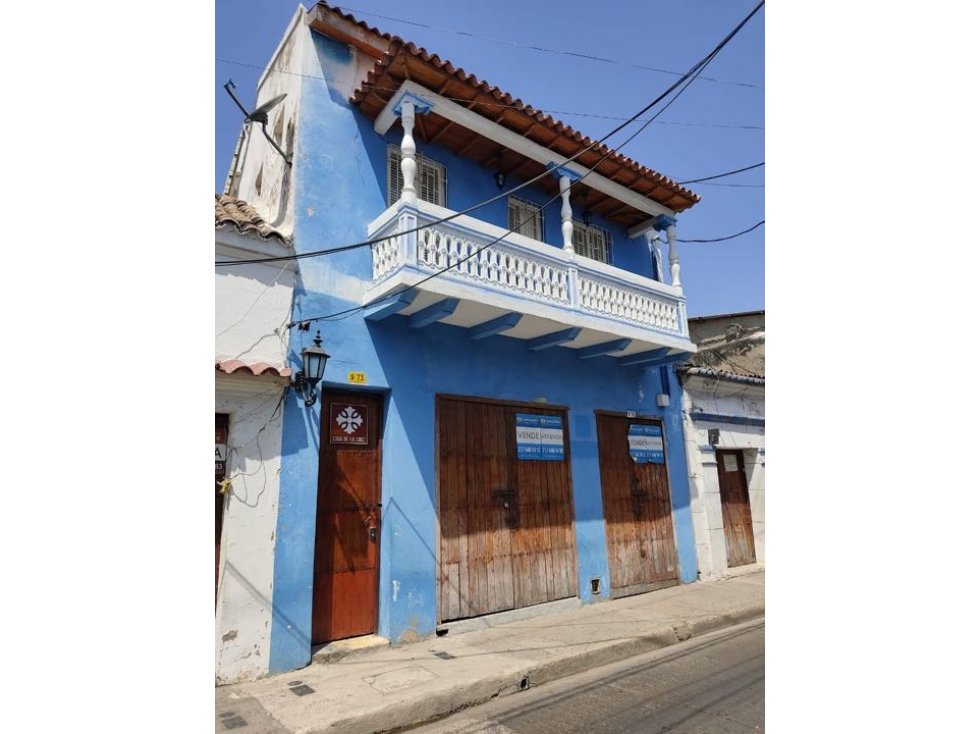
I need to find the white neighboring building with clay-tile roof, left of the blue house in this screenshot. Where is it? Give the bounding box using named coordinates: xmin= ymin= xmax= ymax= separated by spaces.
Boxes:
xmin=214 ymin=195 xmax=295 ymax=683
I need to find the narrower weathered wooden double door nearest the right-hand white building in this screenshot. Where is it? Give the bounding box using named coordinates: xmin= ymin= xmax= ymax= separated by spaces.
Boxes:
xmin=596 ymin=412 xmax=679 ymax=597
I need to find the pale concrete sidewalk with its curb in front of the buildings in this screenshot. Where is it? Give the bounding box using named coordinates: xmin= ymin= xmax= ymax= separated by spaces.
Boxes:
xmin=215 ymin=567 xmax=765 ymax=734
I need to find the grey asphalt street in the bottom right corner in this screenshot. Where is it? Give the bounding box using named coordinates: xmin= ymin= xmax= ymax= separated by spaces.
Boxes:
xmin=412 ymin=620 xmax=765 ymax=734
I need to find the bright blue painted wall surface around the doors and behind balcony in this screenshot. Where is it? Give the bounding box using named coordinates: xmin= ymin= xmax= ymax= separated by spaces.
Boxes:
xmin=270 ymin=28 xmax=696 ymax=673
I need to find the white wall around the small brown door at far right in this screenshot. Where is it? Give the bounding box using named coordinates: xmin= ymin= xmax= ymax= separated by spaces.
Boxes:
xmin=683 ymin=377 xmax=765 ymax=579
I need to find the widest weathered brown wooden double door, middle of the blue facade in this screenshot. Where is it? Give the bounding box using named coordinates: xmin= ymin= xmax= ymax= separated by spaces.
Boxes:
xmin=436 ymin=396 xmax=576 ymax=622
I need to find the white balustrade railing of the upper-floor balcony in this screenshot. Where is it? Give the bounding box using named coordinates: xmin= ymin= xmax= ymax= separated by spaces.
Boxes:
xmin=369 ymin=202 xmax=688 ymax=342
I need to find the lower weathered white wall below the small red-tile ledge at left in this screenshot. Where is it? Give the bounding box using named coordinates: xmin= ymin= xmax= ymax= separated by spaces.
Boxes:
xmin=214 ymin=373 xmax=287 ymax=683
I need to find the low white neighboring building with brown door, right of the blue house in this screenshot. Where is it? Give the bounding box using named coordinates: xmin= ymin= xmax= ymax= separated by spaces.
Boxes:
xmin=677 ymin=311 xmax=765 ymax=579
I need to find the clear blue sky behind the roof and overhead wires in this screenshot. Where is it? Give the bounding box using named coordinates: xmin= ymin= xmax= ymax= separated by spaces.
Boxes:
xmin=214 ymin=0 xmax=765 ymax=316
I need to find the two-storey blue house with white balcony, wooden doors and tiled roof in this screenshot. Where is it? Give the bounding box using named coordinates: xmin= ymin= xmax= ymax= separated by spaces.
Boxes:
xmin=228 ymin=3 xmax=698 ymax=672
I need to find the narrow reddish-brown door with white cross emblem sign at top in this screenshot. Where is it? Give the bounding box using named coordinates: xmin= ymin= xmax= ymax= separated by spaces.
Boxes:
xmin=313 ymin=391 xmax=381 ymax=643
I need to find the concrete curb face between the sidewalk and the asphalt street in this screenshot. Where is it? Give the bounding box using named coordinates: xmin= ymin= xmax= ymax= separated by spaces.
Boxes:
xmin=310 ymin=603 xmax=765 ymax=734
